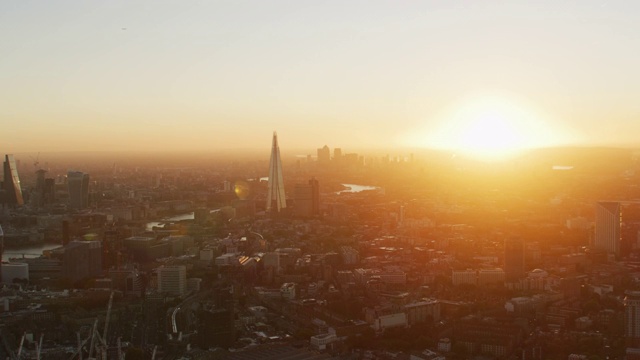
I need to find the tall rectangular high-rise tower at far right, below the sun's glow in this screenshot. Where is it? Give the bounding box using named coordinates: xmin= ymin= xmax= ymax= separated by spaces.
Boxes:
xmin=594 ymin=202 xmax=622 ymax=256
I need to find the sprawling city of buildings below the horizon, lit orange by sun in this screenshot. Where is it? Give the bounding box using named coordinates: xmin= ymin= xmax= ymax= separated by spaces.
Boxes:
xmin=0 ymin=139 xmax=640 ymax=359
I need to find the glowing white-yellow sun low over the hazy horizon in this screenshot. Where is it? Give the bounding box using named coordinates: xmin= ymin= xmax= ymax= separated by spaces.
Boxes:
xmin=411 ymin=96 xmax=560 ymax=161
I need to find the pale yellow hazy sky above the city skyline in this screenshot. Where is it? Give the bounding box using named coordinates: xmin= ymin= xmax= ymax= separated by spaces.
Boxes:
xmin=0 ymin=0 xmax=640 ymax=152
